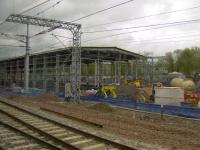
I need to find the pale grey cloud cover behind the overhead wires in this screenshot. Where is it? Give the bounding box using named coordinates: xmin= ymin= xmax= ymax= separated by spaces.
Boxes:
xmin=0 ymin=0 xmax=200 ymax=59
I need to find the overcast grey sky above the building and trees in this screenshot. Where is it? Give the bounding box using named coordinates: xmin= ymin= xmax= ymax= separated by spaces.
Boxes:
xmin=0 ymin=0 xmax=200 ymax=59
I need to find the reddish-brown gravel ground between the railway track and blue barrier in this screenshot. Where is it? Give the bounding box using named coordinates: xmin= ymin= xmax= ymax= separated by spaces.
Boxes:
xmin=2 ymin=94 xmax=200 ymax=150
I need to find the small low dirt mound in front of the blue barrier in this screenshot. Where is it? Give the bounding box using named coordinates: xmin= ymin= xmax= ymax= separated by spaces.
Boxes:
xmin=89 ymin=103 xmax=113 ymax=113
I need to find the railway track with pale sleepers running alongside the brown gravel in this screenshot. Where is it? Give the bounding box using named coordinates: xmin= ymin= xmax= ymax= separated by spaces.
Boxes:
xmin=0 ymin=100 xmax=135 ymax=150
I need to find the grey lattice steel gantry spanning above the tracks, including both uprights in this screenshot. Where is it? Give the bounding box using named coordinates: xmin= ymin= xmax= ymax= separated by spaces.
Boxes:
xmin=6 ymin=14 xmax=81 ymax=100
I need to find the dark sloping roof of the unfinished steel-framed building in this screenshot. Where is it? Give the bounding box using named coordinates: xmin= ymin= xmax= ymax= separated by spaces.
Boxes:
xmin=0 ymin=47 xmax=145 ymax=63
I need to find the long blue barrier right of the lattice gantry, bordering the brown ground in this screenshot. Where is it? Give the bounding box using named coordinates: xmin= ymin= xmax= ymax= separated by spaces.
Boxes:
xmin=81 ymin=96 xmax=200 ymax=119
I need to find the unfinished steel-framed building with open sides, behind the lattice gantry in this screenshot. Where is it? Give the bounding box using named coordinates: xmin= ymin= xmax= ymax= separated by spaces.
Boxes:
xmin=0 ymin=47 xmax=145 ymax=93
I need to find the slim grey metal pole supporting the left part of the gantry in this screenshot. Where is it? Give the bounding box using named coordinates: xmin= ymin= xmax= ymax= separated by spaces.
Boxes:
xmin=25 ymin=24 xmax=29 ymax=92
